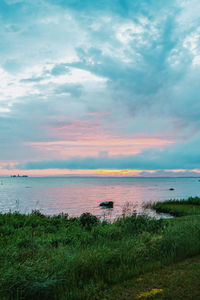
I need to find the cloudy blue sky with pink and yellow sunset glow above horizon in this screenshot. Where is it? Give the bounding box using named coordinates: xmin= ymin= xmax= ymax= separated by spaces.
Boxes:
xmin=0 ymin=0 xmax=200 ymax=176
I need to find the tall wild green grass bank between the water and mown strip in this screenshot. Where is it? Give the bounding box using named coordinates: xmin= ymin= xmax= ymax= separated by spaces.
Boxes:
xmin=0 ymin=211 xmax=200 ymax=300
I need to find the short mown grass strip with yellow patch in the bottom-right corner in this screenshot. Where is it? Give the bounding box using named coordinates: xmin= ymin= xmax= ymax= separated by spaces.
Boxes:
xmin=100 ymin=256 xmax=200 ymax=300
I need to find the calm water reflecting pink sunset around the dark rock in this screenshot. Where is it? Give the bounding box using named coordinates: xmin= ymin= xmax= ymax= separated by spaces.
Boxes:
xmin=0 ymin=177 xmax=200 ymax=219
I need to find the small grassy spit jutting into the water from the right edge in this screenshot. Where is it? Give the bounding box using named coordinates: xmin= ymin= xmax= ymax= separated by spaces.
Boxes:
xmin=146 ymin=197 xmax=200 ymax=217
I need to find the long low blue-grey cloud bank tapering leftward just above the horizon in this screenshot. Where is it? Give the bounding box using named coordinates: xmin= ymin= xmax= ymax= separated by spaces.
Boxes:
xmin=16 ymin=141 xmax=200 ymax=170
